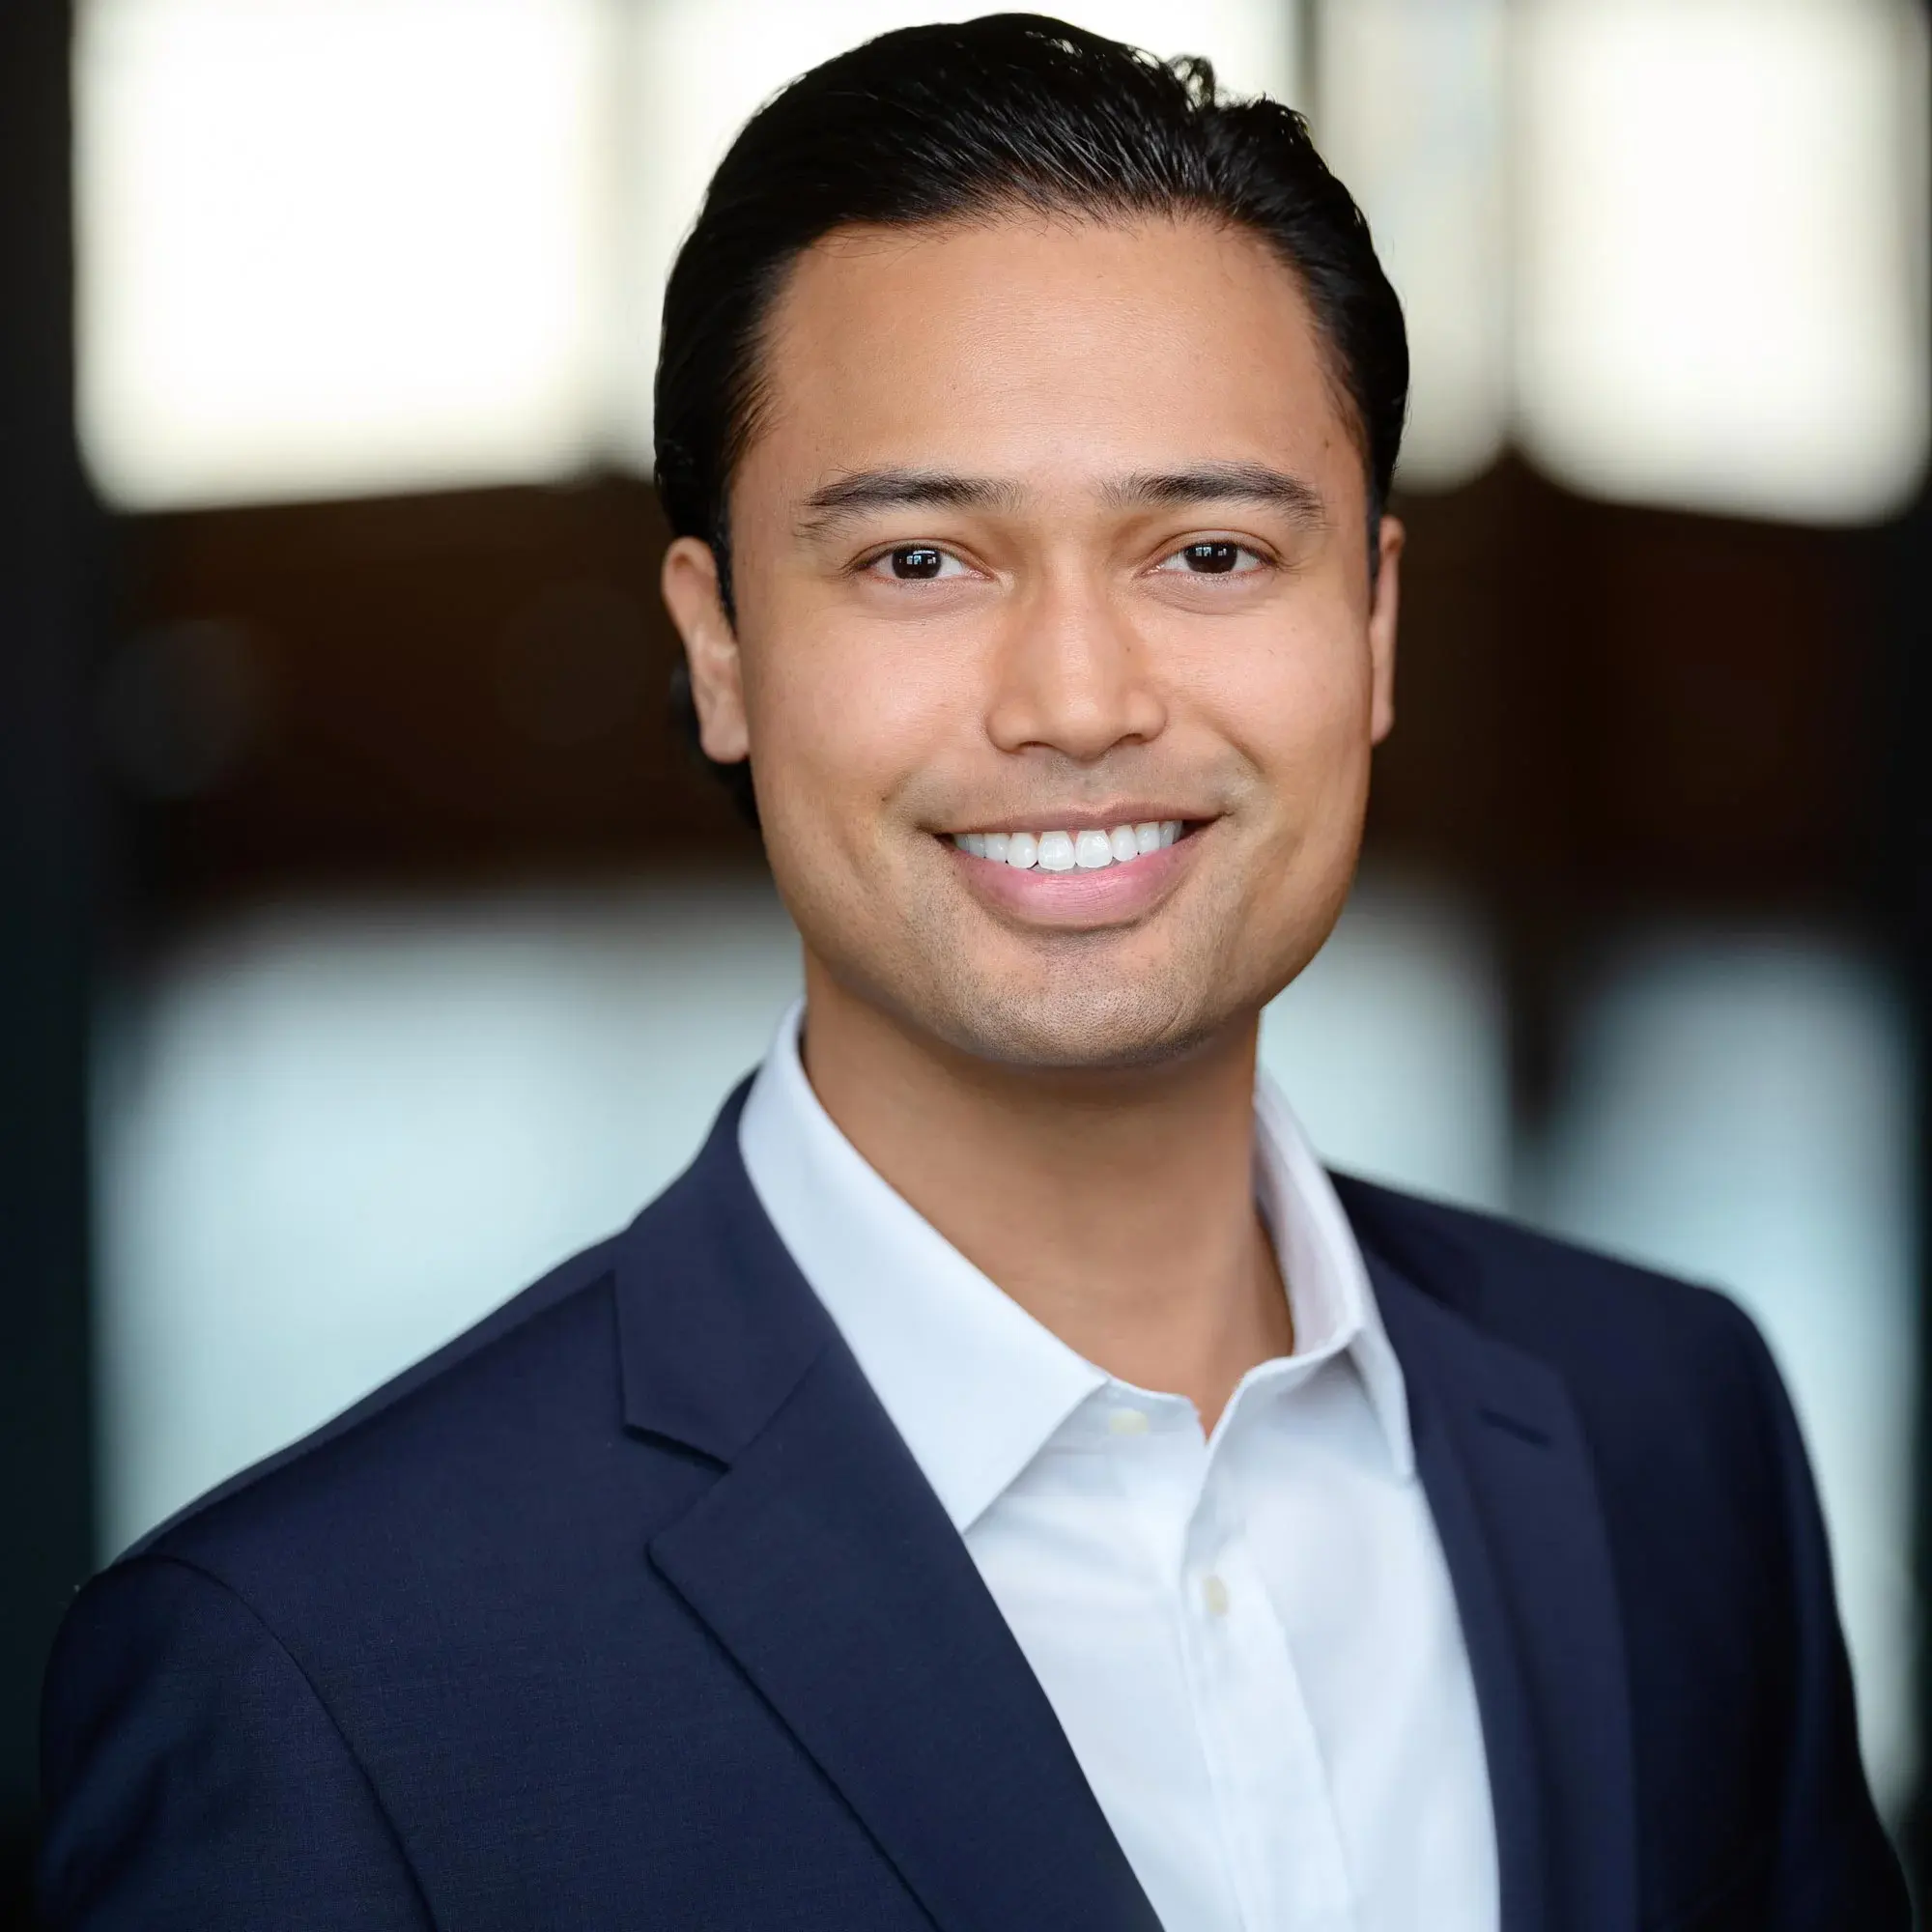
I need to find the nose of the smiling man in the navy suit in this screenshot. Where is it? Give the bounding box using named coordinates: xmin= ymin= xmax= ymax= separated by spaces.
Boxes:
xmin=987 ymin=578 xmax=1167 ymax=765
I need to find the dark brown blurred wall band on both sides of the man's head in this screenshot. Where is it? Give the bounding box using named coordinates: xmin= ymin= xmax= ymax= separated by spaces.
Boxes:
xmin=100 ymin=460 xmax=1884 ymax=920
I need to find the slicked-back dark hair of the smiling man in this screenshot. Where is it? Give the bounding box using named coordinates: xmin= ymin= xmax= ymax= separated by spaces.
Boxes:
xmin=657 ymin=14 xmax=1408 ymax=819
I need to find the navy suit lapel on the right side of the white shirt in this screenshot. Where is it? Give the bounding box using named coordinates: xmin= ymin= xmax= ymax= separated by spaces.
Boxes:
xmin=1350 ymin=1236 xmax=1636 ymax=1932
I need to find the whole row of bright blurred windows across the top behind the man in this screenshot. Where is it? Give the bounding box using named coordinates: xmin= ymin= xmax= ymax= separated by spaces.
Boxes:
xmin=75 ymin=0 xmax=1932 ymax=522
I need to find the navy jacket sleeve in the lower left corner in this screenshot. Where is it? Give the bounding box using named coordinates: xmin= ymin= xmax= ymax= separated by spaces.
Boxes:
xmin=39 ymin=1555 xmax=431 ymax=1932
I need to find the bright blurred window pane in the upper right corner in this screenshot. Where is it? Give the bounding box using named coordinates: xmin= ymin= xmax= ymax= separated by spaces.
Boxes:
xmin=1517 ymin=0 xmax=1928 ymax=524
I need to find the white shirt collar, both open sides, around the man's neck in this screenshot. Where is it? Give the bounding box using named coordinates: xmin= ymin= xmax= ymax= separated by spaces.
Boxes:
xmin=738 ymin=1001 xmax=1414 ymax=1532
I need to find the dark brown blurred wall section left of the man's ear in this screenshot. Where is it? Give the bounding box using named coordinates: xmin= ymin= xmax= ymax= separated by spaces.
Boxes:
xmin=99 ymin=477 xmax=757 ymax=912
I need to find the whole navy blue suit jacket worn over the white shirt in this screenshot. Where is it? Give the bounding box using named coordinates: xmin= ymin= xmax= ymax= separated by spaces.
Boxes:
xmin=43 ymin=1101 xmax=1909 ymax=1932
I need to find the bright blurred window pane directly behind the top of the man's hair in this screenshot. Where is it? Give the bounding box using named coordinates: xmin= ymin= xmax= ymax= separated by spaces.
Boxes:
xmin=616 ymin=0 xmax=1294 ymax=468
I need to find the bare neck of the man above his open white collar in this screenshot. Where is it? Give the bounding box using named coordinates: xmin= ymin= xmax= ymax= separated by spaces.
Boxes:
xmin=806 ymin=954 xmax=1293 ymax=1428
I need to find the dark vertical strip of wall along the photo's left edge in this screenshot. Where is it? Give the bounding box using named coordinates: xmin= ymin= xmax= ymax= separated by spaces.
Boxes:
xmin=0 ymin=4 xmax=93 ymax=1924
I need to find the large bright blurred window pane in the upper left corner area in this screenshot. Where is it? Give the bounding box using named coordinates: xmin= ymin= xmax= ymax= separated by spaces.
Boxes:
xmin=75 ymin=0 xmax=609 ymax=508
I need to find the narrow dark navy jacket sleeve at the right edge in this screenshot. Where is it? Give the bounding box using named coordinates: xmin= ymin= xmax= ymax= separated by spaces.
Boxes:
xmin=1737 ymin=1318 xmax=1913 ymax=1932
